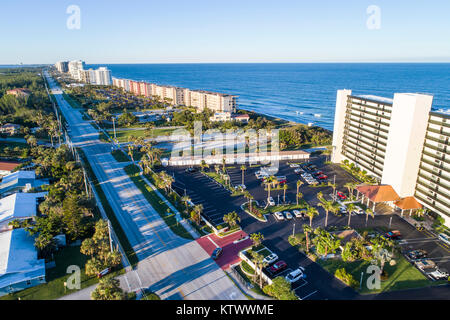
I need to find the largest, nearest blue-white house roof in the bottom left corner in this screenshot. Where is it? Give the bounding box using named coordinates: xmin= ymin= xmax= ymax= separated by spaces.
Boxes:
xmin=0 ymin=229 xmax=45 ymax=288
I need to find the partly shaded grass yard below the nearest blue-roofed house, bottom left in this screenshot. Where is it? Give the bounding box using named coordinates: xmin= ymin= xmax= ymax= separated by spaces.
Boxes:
xmin=0 ymin=246 xmax=124 ymax=300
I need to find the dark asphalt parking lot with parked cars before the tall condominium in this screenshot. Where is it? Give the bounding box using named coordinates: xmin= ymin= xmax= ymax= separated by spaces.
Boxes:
xmin=164 ymin=158 xmax=450 ymax=300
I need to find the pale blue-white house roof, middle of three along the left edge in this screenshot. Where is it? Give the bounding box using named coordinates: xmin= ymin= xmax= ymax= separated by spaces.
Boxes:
xmin=0 ymin=192 xmax=38 ymax=223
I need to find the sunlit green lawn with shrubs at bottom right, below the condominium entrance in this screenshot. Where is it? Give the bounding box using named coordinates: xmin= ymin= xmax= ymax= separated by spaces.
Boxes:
xmin=316 ymin=256 xmax=445 ymax=294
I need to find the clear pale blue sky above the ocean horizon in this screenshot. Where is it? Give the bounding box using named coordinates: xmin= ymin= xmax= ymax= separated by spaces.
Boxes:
xmin=0 ymin=0 xmax=450 ymax=64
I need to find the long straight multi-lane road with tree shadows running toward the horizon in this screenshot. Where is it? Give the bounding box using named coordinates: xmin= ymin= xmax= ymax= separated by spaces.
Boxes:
xmin=47 ymin=75 xmax=246 ymax=300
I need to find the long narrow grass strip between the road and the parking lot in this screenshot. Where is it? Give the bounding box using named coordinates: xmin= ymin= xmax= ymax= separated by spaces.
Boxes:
xmin=125 ymin=164 xmax=194 ymax=240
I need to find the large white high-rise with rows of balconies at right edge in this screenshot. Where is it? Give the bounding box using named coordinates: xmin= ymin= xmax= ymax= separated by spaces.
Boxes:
xmin=332 ymin=90 xmax=450 ymax=225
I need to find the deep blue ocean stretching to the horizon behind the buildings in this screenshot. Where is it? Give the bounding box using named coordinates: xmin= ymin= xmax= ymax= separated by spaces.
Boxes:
xmin=88 ymin=63 xmax=450 ymax=130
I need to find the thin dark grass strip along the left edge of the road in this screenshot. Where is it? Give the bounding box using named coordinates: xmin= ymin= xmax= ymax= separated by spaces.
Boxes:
xmin=77 ymin=149 xmax=139 ymax=266
